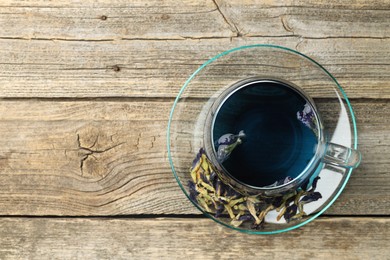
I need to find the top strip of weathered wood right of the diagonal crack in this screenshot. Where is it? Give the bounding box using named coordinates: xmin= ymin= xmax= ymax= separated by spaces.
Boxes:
xmin=216 ymin=0 xmax=390 ymax=38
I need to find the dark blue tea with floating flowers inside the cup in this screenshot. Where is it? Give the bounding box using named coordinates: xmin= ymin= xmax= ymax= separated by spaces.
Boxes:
xmin=212 ymin=80 xmax=317 ymax=187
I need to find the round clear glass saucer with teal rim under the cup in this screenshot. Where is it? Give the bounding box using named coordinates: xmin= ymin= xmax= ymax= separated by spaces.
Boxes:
xmin=167 ymin=44 xmax=357 ymax=234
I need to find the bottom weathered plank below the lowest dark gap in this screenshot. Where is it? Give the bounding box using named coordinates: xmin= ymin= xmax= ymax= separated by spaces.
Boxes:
xmin=0 ymin=218 xmax=390 ymax=259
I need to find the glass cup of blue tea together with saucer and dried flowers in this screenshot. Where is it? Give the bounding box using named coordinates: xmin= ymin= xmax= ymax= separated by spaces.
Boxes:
xmin=167 ymin=44 xmax=360 ymax=234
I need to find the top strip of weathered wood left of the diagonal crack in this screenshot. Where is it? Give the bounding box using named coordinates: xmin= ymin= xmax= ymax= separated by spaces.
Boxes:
xmin=0 ymin=0 xmax=234 ymax=41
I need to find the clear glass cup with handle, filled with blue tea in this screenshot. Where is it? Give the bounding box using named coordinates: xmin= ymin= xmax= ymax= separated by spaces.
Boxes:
xmin=204 ymin=77 xmax=361 ymax=196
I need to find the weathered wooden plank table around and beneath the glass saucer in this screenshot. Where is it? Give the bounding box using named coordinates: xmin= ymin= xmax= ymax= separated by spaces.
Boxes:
xmin=0 ymin=0 xmax=390 ymax=259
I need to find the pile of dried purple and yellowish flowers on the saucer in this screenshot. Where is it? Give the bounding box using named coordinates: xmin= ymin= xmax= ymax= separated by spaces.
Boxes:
xmin=188 ymin=149 xmax=322 ymax=229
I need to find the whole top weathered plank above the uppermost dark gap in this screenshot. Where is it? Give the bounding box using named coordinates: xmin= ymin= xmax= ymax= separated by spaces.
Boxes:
xmin=0 ymin=0 xmax=390 ymax=98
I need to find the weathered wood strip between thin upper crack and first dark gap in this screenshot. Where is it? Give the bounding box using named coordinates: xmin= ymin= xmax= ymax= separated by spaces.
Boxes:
xmin=0 ymin=36 xmax=390 ymax=98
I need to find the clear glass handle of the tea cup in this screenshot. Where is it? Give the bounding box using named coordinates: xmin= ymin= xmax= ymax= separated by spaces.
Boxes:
xmin=323 ymin=143 xmax=362 ymax=169
